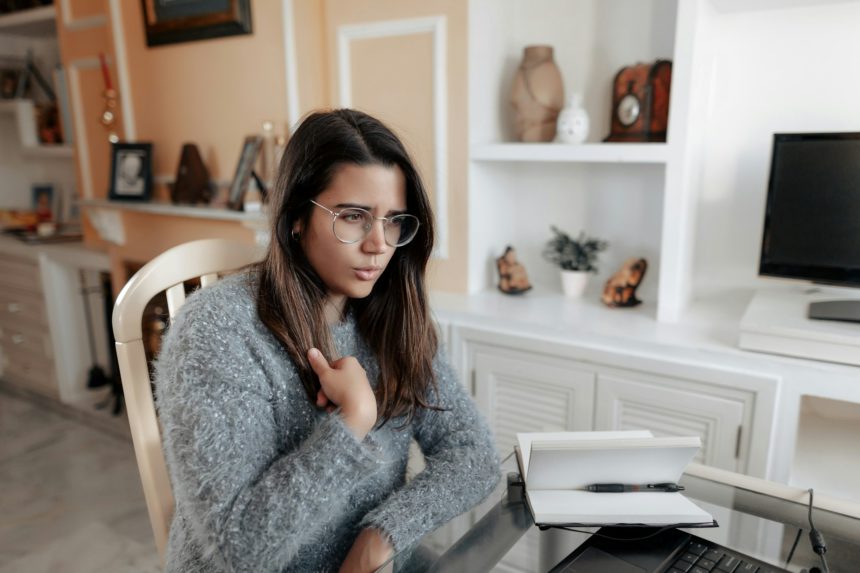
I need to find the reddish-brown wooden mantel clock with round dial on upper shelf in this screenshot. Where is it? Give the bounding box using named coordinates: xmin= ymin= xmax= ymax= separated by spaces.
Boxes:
xmin=603 ymin=60 xmax=672 ymax=141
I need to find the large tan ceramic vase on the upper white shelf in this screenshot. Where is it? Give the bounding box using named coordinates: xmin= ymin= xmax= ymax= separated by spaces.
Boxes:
xmin=511 ymin=46 xmax=564 ymax=142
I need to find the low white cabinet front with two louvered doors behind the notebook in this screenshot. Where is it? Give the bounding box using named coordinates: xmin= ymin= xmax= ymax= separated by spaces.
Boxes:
xmin=450 ymin=321 xmax=779 ymax=477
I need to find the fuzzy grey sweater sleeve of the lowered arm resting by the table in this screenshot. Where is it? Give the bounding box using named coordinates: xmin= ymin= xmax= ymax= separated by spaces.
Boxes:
xmin=362 ymin=344 xmax=501 ymax=551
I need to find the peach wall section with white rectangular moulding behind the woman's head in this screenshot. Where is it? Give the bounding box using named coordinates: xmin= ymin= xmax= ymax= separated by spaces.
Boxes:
xmin=324 ymin=0 xmax=469 ymax=292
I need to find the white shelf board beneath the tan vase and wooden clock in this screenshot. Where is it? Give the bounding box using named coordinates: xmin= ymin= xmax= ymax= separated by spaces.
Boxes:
xmin=472 ymin=143 xmax=669 ymax=163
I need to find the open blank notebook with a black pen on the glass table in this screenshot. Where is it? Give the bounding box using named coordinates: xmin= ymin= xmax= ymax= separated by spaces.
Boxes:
xmin=517 ymin=431 xmax=716 ymax=527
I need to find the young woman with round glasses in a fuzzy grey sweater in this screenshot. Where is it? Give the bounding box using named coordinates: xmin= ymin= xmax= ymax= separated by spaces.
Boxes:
xmin=156 ymin=110 xmax=499 ymax=573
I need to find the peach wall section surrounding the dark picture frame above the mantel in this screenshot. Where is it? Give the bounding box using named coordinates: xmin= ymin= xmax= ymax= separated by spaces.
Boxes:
xmin=116 ymin=0 xmax=287 ymax=187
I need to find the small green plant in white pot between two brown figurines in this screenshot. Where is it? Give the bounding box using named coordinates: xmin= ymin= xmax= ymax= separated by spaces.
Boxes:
xmin=543 ymin=225 xmax=609 ymax=298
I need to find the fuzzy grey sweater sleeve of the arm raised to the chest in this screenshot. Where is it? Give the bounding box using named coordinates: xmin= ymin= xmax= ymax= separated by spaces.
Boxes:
xmin=156 ymin=297 xmax=382 ymax=572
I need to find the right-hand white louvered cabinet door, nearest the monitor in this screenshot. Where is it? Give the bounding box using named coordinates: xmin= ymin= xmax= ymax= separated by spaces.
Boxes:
xmin=594 ymin=372 xmax=745 ymax=471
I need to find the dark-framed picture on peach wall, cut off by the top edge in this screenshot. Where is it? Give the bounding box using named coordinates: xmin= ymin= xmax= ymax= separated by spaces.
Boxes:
xmin=141 ymin=0 xmax=253 ymax=47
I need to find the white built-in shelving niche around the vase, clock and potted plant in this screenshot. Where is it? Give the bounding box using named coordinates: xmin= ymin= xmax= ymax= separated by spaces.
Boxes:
xmin=469 ymin=0 xmax=688 ymax=321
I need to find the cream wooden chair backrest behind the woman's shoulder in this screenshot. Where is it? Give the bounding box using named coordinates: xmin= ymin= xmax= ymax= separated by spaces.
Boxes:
xmin=113 ymin=239 xmax=263 ymax=559
